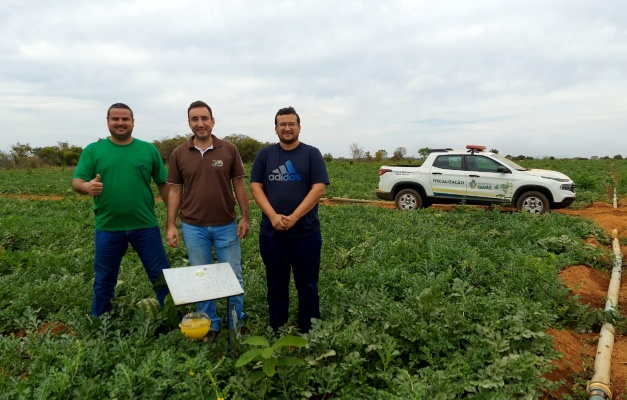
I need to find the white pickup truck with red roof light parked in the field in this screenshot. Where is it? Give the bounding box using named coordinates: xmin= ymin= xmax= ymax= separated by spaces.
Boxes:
xmin=376 ymin=145 xmax=576 ymax=214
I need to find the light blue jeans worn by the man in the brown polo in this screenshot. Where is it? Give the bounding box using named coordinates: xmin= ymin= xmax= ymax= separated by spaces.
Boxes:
xmin=181 ymin=221 xmax=245 ymax=332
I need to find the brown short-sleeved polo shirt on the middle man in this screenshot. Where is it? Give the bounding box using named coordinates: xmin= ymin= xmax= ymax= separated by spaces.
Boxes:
xmin=167 ymin=134 xmax=246 ymax=226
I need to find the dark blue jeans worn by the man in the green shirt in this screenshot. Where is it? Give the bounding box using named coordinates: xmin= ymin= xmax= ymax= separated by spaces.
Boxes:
xmin=91 ymin=226 xmax=170 ymax=316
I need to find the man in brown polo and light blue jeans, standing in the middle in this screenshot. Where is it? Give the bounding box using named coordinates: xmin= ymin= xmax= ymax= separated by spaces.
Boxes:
xmin=166 ymin=101 xmax=250 ymax=340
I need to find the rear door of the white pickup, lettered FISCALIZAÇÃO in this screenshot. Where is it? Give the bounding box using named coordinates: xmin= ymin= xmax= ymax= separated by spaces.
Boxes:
xmin=429 ymin=154 xmax=467 ymax=199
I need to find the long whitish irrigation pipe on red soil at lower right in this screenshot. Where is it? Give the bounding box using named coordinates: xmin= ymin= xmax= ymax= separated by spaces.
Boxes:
xmin=587 ymin=229 xmax=623 ymax=400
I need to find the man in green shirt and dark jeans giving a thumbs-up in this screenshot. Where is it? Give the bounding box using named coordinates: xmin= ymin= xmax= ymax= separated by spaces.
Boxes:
xmin=72 ymin=103 xmax=170 ymax=316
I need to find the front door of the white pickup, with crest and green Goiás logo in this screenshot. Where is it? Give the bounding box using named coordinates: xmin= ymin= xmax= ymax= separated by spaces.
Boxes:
xmin=466 ymin=155 xmax=513 ymax=202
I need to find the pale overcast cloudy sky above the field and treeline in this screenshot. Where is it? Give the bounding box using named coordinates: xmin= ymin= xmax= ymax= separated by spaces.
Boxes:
xmin=0 ymin=0 xmax=627 ymax=157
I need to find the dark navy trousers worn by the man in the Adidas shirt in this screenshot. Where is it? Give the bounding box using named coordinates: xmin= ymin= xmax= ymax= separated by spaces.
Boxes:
xmin=259 ymin=232 xmax=322 ymax=332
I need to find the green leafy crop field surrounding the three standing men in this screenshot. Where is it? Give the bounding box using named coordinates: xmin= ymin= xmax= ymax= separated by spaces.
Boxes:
xmin=0 ymin=160 xmax=627 ymax=399
